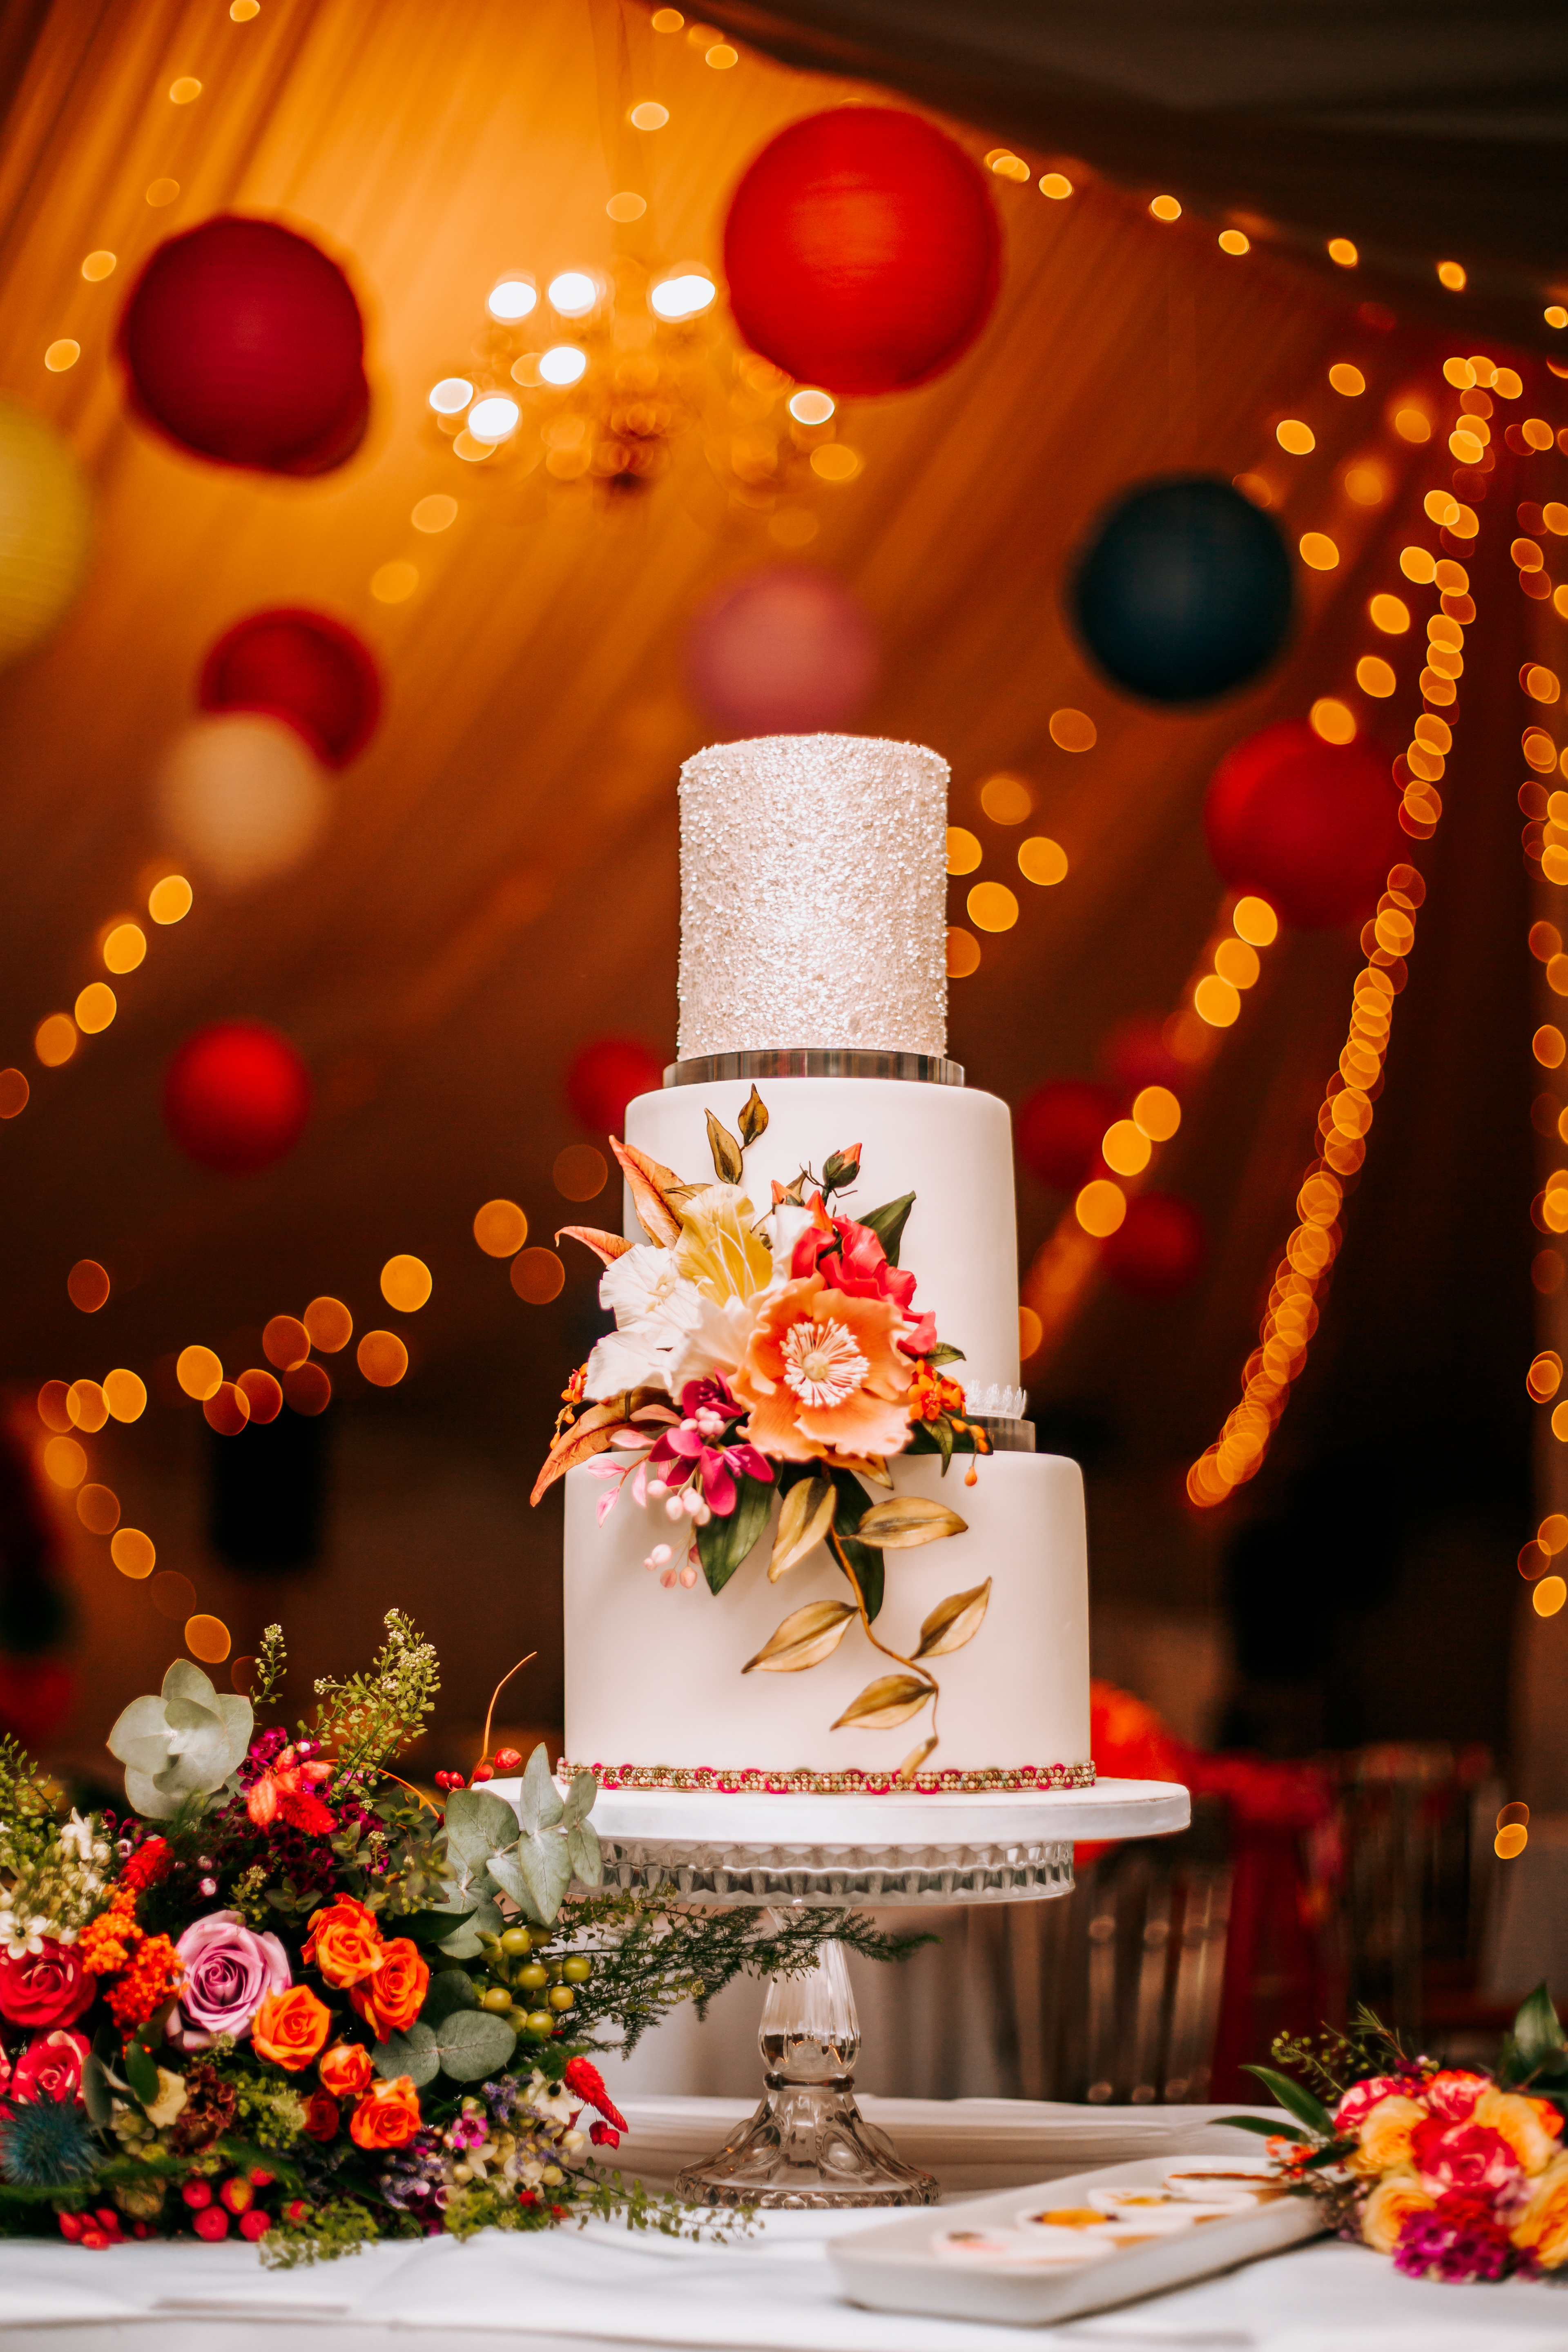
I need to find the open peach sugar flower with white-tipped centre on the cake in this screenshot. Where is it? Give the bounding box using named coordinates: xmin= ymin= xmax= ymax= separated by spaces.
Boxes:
xmin=731 ymin=1275 xmax=914 ymax=1463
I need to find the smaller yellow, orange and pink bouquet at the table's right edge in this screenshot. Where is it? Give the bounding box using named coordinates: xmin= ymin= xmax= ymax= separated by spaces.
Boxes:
xmin=1227 ymin=1985 xmax=1568 ymax=2284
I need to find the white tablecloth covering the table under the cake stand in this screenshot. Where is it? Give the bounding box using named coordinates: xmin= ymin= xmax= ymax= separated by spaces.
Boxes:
xmin=0 ymin=2100 xmax=1568 ymax=2352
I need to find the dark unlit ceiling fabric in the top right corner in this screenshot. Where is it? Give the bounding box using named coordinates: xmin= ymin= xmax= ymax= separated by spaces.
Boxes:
xmin=710 ymin=0 xmax=1568 ymax=348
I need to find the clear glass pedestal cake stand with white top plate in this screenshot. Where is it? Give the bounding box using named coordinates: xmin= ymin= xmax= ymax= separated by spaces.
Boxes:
xmin=576 ymin=1781 xmax=1192 ymax=2209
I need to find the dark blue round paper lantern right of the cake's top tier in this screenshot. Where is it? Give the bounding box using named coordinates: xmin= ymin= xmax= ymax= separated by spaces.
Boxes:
xmin=1070 ymin=473 xmax=1293 ymax=703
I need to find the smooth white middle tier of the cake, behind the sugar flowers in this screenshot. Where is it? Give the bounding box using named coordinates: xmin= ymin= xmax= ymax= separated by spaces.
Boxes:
xmin=623 ymin=1077 xmax=1018 ymax=1411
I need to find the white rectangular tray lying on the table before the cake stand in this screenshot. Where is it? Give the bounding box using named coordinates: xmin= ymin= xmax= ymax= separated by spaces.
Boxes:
xmin=827 ymin=2157 xmax=1328 ymax=2326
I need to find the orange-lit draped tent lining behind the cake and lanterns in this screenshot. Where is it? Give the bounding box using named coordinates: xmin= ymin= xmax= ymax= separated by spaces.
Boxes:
xmin=0 ymin=0 xmax=1552 ymax=1768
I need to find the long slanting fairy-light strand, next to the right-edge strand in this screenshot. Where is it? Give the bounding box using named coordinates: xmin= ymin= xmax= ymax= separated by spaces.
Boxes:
xmin=1187 ymin=355 xmax=1523 ymax=1510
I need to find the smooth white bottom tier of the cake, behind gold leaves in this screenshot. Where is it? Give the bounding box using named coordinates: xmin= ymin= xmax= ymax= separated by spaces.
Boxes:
xmin=567 ymin=1454 xmax=1088 ymax=1773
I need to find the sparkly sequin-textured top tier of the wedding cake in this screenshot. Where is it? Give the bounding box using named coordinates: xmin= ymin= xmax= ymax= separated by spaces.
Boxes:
xmin=677 ymin=736 xmax=948 ymax=1061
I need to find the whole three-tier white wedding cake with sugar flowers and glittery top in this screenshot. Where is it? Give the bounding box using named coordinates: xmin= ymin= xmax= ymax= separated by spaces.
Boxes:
xmin=541 ymin=736 xmax=1093 ymax=1790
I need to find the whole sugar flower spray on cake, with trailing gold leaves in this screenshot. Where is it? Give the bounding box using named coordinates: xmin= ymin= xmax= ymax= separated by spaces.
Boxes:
xmin=534 ymin=1087 xmax=990 ymax=1781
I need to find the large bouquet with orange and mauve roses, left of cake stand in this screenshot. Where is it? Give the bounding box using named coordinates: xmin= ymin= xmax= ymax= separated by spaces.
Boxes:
xmin=0 ymin=1611 xmax=903 ymax=2263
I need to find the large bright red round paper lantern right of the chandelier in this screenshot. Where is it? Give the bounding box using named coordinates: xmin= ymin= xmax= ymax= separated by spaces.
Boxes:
xmin=724 ymin=106 xmax=1001 ymax=393
